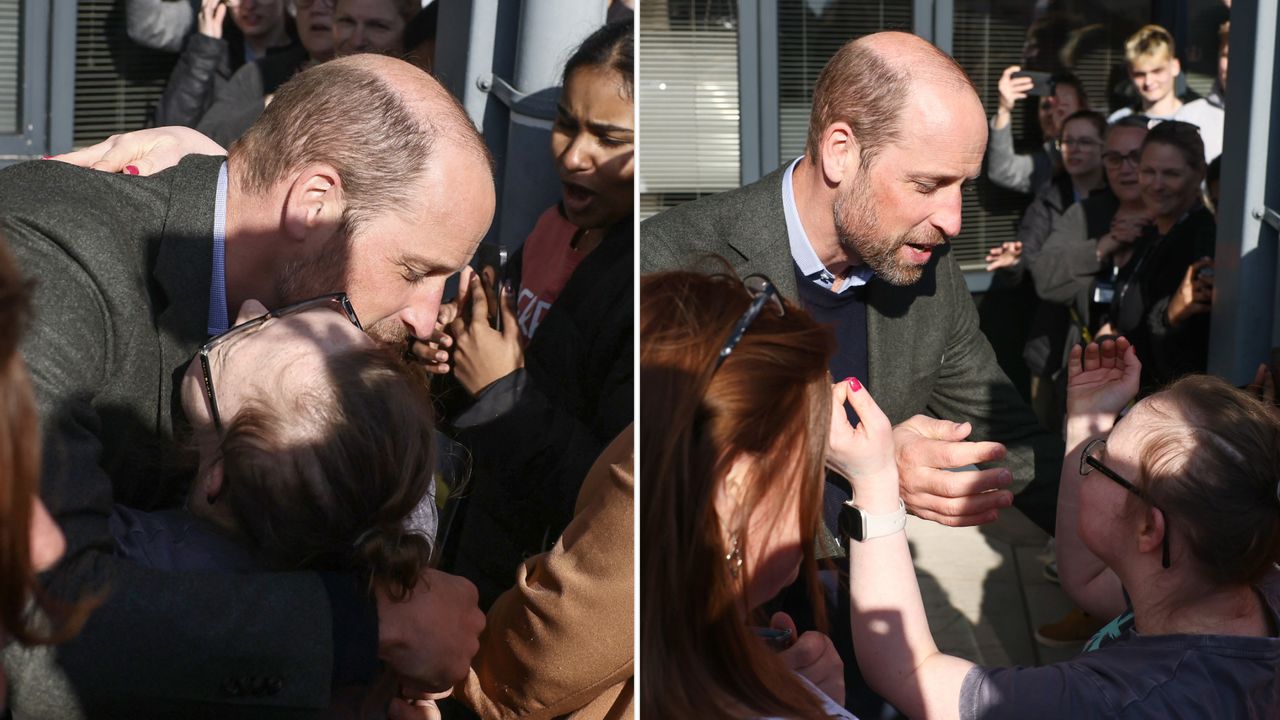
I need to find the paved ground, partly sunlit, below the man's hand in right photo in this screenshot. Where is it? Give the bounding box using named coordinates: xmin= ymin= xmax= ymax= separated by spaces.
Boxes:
xmin=906 ymin=509 xmax=1078 ymax=665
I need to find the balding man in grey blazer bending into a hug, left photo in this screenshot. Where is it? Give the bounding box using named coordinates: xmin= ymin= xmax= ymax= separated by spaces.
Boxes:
xmin=0 ymin=55 xmax=494 ymax=717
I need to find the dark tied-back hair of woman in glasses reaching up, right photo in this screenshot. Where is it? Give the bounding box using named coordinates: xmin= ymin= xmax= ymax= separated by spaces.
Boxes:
xmin=1140 ymin=375 xmax=1280 ymax=584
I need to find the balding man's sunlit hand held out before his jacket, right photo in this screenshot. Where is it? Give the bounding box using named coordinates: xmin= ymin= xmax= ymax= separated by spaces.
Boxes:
xmin=893 ymin=415 xmax=1014 ymax=527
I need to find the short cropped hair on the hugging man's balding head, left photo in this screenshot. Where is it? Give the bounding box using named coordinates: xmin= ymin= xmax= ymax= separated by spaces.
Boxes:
xmin=228 ymin=55 xmax=489 ymax=233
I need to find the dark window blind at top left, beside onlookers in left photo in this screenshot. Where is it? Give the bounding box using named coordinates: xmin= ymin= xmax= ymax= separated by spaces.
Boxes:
xmin=73 ymin=0 xmax=178 ymax=147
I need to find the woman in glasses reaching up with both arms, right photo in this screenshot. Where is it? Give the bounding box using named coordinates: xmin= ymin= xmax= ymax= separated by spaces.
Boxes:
xmin=839 ymin=338 xmax=1280 ymax=720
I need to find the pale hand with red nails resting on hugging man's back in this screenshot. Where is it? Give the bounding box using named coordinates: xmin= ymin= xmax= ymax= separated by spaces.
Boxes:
xmin=49 ymin=127 xmax=227 ymax=176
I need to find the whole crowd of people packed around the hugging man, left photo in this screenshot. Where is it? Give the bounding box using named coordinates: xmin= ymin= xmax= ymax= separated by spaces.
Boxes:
xmin=0 ymin=0 xmax=635 ymax=719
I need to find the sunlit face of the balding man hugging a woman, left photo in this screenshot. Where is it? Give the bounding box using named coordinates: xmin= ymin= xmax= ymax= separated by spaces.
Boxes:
xmin=276 ymin=143 xmax=495 ymax=343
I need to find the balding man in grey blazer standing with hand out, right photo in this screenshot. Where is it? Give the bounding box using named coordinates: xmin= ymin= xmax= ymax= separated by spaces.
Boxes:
xmin=640 ymin=32 xmax=1062 ymax=707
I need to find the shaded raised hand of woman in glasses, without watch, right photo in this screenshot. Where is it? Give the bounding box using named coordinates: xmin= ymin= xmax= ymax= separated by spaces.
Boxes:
xmin=1066 ymin=337 xmax=1142 ymax=427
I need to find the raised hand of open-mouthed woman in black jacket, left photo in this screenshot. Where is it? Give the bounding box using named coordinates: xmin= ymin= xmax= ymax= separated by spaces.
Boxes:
xmin=448 ymin=269 xmax=525 ymax=395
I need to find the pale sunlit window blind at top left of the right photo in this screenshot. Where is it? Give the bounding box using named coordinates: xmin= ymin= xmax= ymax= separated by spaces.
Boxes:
xmin=639 ymin=0 xmax=741 ymax=219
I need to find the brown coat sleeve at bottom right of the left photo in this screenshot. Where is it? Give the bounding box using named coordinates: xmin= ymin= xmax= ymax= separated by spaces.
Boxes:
xmin=458 ymin=425 xmax=635 ymax=720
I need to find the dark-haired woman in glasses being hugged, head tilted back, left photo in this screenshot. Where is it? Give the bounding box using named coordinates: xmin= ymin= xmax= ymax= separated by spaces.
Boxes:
xmin=111 ymin=295 xmax=435 ymax=596
